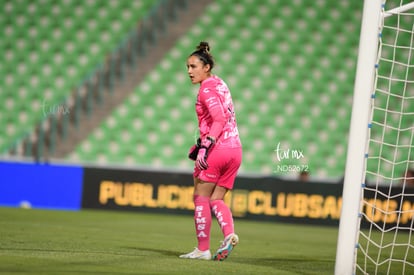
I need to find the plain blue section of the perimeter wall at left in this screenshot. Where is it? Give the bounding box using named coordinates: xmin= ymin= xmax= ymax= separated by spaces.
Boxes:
xmin=0 ymin=162 xmax=84 ymax=210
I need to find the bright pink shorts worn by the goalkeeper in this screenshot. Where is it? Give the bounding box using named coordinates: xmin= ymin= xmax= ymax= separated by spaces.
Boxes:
xmin=193 ymin=147 xmax=242 ymax=189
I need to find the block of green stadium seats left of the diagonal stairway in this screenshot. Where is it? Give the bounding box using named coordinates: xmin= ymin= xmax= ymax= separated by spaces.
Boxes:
xmin=0 ymin=0 xmax=154 ymax=153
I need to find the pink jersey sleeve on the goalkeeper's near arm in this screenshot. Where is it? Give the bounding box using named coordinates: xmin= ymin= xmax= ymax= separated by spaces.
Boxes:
xmin=200 ymin=83 xmax=227 ymax=139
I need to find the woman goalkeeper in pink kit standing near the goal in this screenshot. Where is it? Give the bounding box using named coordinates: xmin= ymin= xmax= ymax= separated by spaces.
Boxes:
xmin=180 ymin=42 xmax=242 ymax=261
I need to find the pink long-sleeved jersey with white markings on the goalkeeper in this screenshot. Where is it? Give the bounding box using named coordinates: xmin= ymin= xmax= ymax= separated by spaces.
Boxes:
xmin=196 ymin=75 xmax=241 ymax=148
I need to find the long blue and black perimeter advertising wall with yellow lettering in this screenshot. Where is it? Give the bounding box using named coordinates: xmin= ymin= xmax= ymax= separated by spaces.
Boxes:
xmin=0 ymin=162 xmax=414 ymax=227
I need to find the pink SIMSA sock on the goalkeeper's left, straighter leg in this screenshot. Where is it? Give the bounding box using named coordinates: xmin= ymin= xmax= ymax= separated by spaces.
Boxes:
xmin=194 ymin=195 xmax=211 ymax=251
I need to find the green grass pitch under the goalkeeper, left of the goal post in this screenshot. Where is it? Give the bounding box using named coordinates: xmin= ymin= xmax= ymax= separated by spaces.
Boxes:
xmin=0 ymin=208 xmax=338 ymax=275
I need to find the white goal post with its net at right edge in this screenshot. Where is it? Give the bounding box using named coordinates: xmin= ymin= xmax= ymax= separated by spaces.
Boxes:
xmin=335 ymin=0 xmax=414 ymax=274
